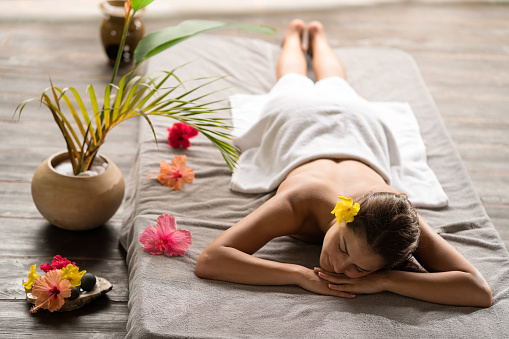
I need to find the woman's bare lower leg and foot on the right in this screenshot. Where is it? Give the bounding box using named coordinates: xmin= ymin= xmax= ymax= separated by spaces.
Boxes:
xmin=308 ymin=21 xmax=346 ymax=81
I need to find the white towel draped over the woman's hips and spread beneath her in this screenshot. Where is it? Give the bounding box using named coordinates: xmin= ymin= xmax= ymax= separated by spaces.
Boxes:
xmin=230 ymin=74 xmax=448 ymax=207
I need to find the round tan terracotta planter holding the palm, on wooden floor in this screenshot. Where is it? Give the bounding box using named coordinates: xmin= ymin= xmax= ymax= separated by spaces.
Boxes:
xmin=32 ymin=152 xmax=125 ymax=231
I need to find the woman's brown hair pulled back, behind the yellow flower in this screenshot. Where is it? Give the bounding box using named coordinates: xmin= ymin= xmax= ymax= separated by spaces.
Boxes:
xmin=346 ymin=192 xmax=420 ymax=269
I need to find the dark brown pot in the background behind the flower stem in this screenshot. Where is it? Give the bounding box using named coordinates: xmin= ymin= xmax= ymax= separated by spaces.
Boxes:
xmin=99 ymin=0 xmax=145 ymax=66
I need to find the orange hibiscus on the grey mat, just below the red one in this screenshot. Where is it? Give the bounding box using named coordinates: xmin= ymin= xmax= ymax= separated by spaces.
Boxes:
xmin=157 ymin=155 xmax=194 ymax=190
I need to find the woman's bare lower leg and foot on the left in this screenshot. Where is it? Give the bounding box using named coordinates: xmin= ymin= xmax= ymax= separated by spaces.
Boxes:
xmin=277 ymin=19 xmax=307 ymax=79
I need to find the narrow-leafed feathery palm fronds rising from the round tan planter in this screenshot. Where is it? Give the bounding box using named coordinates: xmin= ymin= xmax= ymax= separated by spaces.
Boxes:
xmin=15 ymin=70 xmax=238 ymax=174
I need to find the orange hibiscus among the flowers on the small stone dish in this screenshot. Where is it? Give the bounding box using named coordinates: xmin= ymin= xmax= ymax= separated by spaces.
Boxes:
xmin=30 ymin=270 xmax=71 ymax=313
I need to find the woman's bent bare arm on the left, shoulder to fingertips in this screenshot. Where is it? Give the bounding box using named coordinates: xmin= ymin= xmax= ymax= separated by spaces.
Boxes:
xmin=195 ymin=192 xmax=354 ymax=298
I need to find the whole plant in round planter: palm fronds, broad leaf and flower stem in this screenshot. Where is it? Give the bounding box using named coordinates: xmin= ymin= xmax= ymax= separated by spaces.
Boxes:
xmin=15 ymin=0 xmax=274 ymax=175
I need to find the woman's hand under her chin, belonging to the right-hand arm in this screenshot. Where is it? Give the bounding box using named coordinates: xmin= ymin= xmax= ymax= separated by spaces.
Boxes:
xmin=314 ymin=268 xmax=385 ymax=295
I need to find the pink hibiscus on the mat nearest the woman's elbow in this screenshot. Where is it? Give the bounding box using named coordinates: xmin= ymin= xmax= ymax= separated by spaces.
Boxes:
xmin=139 ymin=214 xmax=191 ymax=257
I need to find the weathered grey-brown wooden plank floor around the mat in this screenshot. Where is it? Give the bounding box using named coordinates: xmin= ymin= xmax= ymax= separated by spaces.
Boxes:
xmin=0 ymin=2 xmax=509 ymax=338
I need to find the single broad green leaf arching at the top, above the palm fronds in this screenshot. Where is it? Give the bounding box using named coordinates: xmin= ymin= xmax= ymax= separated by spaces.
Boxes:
xmin=134 ymin=20 xmax=275 ymax=67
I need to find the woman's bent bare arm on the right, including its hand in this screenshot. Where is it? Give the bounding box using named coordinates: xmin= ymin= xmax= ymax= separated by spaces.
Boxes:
xmin=317 ymin=218 xmax=492 ymax=307
